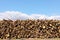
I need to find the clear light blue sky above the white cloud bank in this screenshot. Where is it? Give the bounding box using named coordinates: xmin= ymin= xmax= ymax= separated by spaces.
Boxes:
xmin=0 ymin=0 xmax=60 ymax=16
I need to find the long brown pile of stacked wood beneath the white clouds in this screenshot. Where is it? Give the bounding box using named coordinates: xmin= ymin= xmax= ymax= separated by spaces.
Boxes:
xmin=0 ymin=20 xmax=60 ymax=39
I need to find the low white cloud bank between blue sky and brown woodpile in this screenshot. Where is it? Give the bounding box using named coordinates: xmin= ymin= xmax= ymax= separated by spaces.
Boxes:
xmin=0 ymin=11 xmax=60 ymax=20
